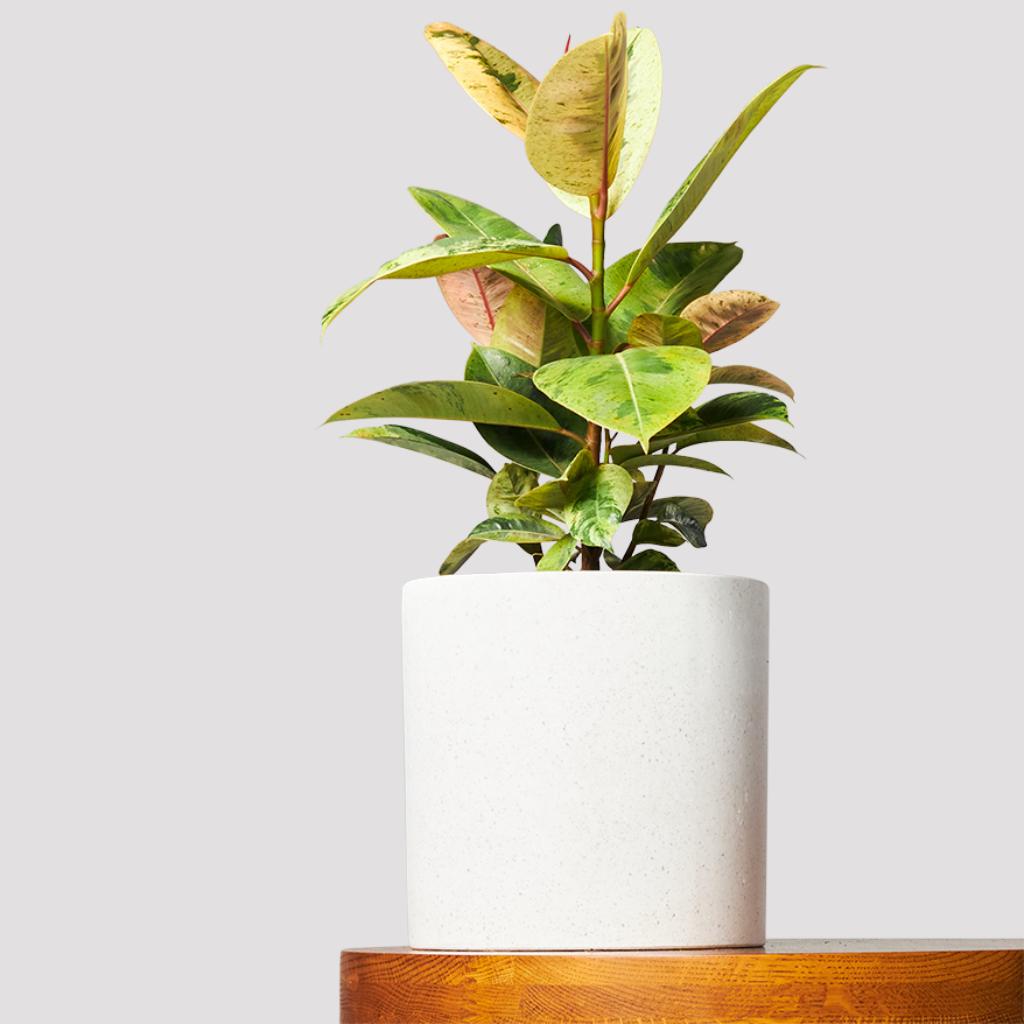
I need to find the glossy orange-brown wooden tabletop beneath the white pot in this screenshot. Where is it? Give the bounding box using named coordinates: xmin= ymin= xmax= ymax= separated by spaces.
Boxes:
xmin=341 ymin=939 xmax=1024 ymax=1024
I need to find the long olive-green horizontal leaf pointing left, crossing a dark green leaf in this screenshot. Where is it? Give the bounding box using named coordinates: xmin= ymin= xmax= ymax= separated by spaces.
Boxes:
xmin=327 ymin=381 xmax=559 ymax=431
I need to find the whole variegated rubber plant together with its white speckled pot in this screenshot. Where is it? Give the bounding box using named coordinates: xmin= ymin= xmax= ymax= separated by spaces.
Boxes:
xmin=323 ymin=14 xmax=810 ymax=948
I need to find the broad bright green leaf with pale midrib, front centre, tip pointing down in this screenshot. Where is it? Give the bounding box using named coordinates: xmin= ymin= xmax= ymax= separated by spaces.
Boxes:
xmin=534 ymin=347 xmax=711 ymax=451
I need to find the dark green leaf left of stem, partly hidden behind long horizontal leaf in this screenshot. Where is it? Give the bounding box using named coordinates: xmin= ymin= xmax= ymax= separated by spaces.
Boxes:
xmin=466 ymin=348 xmax=587 ymax=476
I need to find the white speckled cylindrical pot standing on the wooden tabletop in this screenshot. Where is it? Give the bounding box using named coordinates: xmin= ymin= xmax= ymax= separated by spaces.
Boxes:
xmin=402 ymin=572 xmax=768 ymax=949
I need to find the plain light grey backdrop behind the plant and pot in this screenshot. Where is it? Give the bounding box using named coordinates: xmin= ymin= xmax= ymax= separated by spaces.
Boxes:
xmin=0 ymin=0 xmax=1024 ymax=1024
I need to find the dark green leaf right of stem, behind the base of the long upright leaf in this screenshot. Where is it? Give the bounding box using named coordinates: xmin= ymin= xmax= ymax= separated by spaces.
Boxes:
xmin=606 ymin=242 xmax=743 ymax=346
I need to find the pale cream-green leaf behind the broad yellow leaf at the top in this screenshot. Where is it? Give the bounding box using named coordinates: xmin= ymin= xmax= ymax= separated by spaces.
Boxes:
xmin=552 ymin=29 xmax=662 ymax=217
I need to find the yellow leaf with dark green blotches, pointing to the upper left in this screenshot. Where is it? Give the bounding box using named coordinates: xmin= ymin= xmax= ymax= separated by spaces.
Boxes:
xmin=423 ymin=22 xmax=538 ymax=138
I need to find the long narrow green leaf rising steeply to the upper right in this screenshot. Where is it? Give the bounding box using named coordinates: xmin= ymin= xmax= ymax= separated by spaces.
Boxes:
xmin=626 ymin=65 xmax=816 ymax=282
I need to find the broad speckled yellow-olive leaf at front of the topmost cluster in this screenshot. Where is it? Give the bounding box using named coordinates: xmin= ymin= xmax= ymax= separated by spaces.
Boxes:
xmin=526 ymin=14 xmax=627 ymax=196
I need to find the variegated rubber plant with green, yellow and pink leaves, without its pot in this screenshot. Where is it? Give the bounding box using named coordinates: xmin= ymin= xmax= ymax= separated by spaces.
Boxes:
xmin=323 ymin=14 xmax=813 ymax=574
